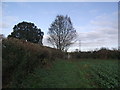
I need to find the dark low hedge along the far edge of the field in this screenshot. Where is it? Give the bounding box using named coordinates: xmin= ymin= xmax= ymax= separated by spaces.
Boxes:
xmin=70 ymin=48 xmax=120 ymax=59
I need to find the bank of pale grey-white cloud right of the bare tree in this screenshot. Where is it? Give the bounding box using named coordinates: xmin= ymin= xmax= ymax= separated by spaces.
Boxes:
xmin=72 ymin=12 xmax=118 ymax=48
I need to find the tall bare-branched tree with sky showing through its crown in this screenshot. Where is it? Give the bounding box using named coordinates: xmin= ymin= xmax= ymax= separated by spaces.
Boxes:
xmin=48 ymin=15 xmax=76 ymax=51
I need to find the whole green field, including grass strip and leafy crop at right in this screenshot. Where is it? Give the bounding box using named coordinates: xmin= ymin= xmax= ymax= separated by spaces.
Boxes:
xmin=12 ymin=59 xmax=120 ymax=88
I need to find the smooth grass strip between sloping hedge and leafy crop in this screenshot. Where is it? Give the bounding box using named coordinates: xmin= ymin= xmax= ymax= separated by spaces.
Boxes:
xmin=21 ymin=60 xmax=119 ymax=88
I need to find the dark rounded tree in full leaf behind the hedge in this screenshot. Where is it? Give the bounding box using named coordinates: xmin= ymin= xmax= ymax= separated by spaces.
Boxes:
xmin=8 ymin=21 xmax=44 ymax=45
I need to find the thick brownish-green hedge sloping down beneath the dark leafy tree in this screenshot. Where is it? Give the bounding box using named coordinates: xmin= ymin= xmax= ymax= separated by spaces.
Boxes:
xmin=2 ymin=38 xmax=63 ymax=87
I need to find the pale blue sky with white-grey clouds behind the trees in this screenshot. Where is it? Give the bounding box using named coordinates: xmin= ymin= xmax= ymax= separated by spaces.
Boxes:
xmin=2 ymin=2 xmax=118 ymax=51
